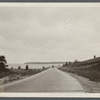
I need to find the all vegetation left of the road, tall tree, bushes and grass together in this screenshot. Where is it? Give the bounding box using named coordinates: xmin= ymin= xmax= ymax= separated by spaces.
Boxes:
xmin=0 ymin=56 xmax=48 ymax=84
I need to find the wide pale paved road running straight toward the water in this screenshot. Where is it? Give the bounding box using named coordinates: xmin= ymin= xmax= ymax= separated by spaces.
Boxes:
xmin=0 ymin=68 xmax=84 ymax=92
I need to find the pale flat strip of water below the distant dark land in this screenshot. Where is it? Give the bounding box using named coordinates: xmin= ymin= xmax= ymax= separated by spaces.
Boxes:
xmin=8 ymin=64 xmax=62 ymax=69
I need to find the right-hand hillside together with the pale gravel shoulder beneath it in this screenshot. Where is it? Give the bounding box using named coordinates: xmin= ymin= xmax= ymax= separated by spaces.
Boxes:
xmin=58 ymin=58 xmax=100 ymax=93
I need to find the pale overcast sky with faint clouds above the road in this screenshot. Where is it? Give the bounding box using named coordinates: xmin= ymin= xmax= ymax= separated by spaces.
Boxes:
xmin=0 ymin=6 xmax=100 ymax=63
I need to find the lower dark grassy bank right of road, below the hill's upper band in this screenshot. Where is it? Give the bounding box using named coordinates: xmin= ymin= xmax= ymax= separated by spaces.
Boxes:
xmin=59 ymin=63 xmax=100 ymax=82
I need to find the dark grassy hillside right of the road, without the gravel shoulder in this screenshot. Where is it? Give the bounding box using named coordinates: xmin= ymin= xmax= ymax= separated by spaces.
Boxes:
xmin=59 ymin=58 xmax=100 ymax=82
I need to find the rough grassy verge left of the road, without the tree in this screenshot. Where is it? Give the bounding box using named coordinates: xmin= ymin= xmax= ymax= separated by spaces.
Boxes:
xmin=0 ymin=68 xmax=48 ymax=85
